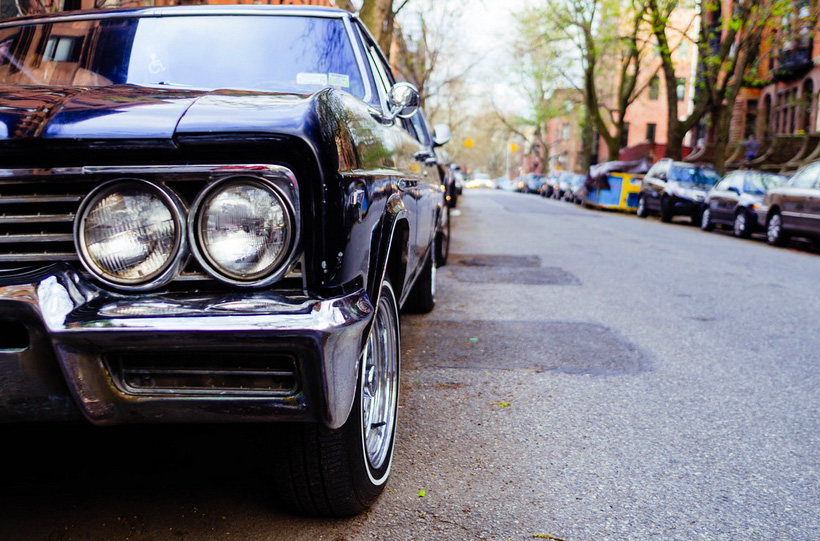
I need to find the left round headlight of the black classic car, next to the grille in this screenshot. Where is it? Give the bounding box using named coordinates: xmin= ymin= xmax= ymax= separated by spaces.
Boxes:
xmin=75 ymin=180 xmax=184 ymax=286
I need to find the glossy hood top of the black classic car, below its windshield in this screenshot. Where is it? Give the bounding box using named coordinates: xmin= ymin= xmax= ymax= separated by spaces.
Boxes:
xmin=0 ymin=85 xmax=310 ymax=144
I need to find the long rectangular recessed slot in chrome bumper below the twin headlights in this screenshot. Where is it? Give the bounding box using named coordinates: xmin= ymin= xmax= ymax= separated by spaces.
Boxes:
xmin=106 ymin=352 xmax=299 ymax=396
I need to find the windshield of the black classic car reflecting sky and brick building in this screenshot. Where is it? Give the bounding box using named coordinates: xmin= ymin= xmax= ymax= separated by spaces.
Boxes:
xmin=0 ymin=15 xmax=365 ymax=98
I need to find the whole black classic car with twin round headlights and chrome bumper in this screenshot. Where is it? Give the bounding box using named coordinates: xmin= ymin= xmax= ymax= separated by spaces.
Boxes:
xmin=0 ymin=6 xmax=446 ymax=516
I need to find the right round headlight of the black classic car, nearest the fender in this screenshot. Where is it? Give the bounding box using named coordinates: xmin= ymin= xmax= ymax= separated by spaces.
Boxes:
xmin=194 ymin=179 xmax=293 ymax=283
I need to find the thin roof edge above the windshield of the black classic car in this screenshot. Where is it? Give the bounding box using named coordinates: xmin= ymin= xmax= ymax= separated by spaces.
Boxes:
xmin=0 ymin=4 xmax=353 ymax=28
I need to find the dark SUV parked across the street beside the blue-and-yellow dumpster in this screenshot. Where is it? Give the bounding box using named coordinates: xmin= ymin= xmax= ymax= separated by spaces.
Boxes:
xmin=636 ymin=158 xmax=720 ymax=224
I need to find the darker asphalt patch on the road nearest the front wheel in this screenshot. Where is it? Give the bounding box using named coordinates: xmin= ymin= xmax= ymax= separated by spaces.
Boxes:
xmin=402 ymin=320 xmax=650 ymax=376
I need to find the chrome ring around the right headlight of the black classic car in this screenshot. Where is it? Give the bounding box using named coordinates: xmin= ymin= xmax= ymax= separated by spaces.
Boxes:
xmin=188 ymin=175 xmax=299 ymax=287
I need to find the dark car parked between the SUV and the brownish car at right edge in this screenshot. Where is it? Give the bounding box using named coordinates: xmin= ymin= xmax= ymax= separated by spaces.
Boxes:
xmin=700 ymin=170 xmax=788 ymax=238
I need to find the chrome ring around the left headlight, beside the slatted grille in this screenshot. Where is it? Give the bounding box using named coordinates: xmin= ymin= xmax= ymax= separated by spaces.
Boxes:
xmin=74 ymin=177 xmax=188 ymax=291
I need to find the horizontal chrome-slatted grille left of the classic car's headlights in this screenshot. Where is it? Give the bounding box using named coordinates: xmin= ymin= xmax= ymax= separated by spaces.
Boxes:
xmin=0 ymin=180 xmax=92 ymax=269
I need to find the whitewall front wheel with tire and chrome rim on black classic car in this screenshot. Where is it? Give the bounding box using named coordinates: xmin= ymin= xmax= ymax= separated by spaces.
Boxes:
xmin=274 ymin=280 xmax=401 ymax=517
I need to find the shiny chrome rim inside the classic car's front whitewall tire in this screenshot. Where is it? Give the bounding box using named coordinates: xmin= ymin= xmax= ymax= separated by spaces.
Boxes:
xmin=361 ymin=288 xmax=399 ymax=470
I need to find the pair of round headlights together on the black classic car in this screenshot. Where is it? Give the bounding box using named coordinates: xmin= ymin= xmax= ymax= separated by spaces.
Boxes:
xmin=74 ymin=177 xmax=295 ymax=290
